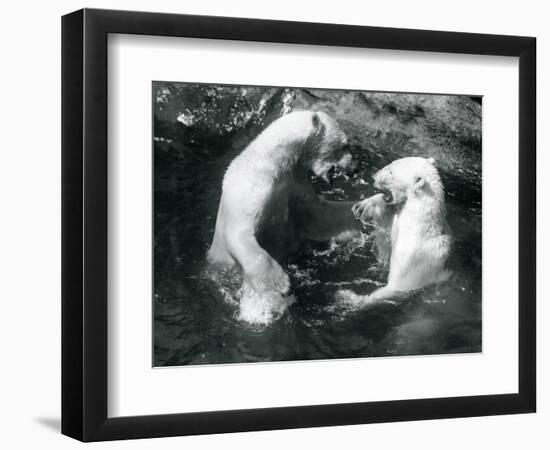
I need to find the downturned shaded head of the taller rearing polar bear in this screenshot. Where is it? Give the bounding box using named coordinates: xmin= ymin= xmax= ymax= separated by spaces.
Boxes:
xmin=305 ymin=112 xmax=354 ymax=183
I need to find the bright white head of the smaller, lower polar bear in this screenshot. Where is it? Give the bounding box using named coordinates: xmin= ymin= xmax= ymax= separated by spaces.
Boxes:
xmin=373 ymin=157 xmax=443 ymax=205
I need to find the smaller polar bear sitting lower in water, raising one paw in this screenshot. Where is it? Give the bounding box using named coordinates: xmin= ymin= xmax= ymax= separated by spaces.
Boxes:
xmin=338 ymin=157 xmax=452 ymax=304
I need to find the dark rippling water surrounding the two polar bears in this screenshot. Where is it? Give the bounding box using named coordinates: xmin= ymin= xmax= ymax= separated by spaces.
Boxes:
xmin=154 ymin=84 xmax=481 ymax=366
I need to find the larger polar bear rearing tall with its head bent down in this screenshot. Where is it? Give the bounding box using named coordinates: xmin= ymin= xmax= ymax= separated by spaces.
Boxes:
xmin=207 ymin=111 xmax=360 ymax=323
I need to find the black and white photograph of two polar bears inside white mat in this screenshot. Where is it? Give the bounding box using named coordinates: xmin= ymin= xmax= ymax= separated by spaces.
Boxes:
xmin=152 ymin=81 xmax=482 ymax=367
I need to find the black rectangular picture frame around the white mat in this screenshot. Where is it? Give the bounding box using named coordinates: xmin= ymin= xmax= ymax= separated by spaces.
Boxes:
xmin=62 ymin=9 xmax=536 ymax=441
